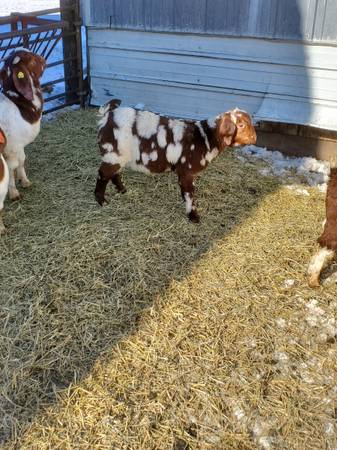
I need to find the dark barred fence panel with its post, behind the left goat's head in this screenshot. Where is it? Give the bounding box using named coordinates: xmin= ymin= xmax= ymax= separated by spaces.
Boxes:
xmin=0 ymin=4 xmax=86 ymax=113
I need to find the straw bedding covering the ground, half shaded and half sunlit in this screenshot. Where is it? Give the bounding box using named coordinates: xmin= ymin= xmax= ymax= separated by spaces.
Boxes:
xmin=0 ymin=112 xmax=337 ymax=450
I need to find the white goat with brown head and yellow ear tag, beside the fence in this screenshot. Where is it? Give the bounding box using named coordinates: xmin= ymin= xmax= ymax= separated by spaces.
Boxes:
xmin=0 ymin=48 xmax=46 ymax=200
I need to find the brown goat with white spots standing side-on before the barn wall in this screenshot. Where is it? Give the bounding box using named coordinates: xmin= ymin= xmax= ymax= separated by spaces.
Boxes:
xmin=95 ymin=100 xmax=256 ymax=222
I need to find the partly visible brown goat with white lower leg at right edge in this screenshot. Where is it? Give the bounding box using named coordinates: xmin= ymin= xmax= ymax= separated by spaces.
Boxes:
xmin=308 ymin=167 xmax=337 ymax=287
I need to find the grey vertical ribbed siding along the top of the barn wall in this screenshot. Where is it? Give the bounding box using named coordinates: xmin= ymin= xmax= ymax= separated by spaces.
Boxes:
xmin=82 ymin=0 xmax=337 ymax=42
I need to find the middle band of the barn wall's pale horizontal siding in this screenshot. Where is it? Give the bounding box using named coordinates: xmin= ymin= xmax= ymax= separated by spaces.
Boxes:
xmin=87 ymin=48 xmax=337 ymax=103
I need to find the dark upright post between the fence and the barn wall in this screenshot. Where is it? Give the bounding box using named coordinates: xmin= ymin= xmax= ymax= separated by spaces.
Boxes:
xmin=60 ymin=0 xmax=83 ymax=105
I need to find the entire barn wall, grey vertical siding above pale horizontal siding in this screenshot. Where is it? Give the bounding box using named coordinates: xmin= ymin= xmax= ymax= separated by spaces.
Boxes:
xmin=82 ymin=0 xmax=337 ymax=129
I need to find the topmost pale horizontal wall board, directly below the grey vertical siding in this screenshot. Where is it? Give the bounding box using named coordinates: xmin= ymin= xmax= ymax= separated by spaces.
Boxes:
xmin=88 ymin=29 xmax=337 ymax=70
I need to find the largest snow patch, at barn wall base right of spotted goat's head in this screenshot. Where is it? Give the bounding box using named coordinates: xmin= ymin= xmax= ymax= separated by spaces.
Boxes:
xmin=238 ymin=145 xmax=330 ymax=188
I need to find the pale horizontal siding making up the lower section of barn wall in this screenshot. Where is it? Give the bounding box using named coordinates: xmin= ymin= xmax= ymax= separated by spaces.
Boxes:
xmin=89 ymin=29 xmax=337 ymax=129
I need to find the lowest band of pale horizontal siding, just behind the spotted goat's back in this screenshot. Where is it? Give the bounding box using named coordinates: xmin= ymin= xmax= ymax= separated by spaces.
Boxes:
xmin=92 ymin=77 xmax=337 ymax=130
